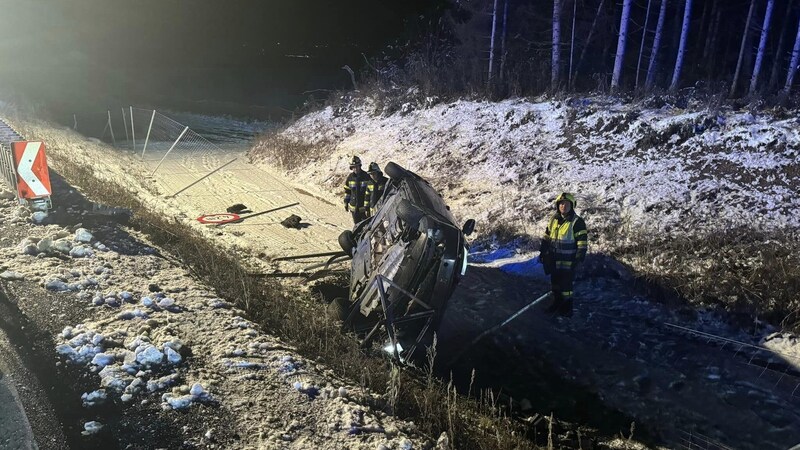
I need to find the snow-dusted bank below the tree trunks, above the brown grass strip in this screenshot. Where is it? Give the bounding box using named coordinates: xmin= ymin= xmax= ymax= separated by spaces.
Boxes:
xmin=264 ymin=99 xmax=800 ymax=249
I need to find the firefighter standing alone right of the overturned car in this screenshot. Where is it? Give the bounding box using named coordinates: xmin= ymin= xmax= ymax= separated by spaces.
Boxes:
xmin=540 ymin=192 xmax=588 ymax=317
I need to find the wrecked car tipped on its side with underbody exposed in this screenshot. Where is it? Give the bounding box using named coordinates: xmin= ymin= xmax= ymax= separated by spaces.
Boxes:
xmin=329 ymin=162 xmax=475 ymax=361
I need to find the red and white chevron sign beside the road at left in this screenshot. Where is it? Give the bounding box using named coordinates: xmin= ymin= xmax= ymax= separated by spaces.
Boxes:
xmin=11 ymin=142 xmax=52 ymax=199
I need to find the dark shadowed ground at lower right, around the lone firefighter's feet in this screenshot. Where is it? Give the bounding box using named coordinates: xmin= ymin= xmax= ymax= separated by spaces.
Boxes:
xmin=439 ymin=251 xmax=800 ymax=449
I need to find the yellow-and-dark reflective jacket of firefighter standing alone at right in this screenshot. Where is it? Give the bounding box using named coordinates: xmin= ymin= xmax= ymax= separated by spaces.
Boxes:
xmin=543 ymin=211 xmax=588 ymax=270
